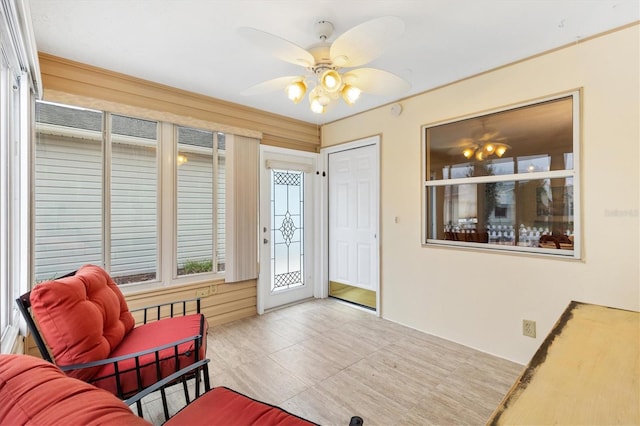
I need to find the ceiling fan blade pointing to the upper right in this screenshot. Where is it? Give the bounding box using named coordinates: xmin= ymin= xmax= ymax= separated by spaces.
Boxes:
xmin=330 ymin=16 xmax=404 ymax=67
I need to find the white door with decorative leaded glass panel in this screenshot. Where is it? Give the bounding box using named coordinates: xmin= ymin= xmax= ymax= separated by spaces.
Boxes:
xmin=258 ymin=146 xmax=316 ymax=313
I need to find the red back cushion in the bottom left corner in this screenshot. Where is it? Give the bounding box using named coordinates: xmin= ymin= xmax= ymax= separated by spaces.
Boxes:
xmin=0 ymin=355 xmax=150 ymax=426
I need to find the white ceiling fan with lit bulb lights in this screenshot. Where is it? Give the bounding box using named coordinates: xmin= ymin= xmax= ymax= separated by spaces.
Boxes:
xmin=238 ymin=16 xmax=410 ymax=114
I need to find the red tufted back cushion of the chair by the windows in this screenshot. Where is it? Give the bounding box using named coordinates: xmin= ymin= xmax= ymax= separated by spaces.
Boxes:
xmin=31 ymin=265 xmax=135 ymax=380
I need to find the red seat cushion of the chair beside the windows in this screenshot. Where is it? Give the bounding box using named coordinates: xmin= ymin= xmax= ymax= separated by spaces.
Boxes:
xmin=91 ymin=314 xmax=207 ymax=395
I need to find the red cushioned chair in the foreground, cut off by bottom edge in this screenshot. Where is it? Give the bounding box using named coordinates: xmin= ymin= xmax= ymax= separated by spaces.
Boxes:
xmin=0 ymin=355 xmax=320 ymax=426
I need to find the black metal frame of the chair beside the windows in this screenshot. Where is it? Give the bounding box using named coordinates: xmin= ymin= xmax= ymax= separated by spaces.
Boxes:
xmin=16 ymin=272 xmax=211 ymax=420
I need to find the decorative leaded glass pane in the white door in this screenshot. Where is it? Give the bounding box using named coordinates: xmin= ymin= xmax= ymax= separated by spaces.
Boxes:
xmin=271 ymin=169 xmax=304 ymax=291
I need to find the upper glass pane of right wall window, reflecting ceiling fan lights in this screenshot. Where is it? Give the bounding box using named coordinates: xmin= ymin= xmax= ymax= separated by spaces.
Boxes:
xmin=426 ymin=97 xmax=573 ymax=180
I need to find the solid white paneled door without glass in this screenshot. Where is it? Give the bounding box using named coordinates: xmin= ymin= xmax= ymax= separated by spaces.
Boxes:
xmin=328 ymin=138 xmax=379 ymax=293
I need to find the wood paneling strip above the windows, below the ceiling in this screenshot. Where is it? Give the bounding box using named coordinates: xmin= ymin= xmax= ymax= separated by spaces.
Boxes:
xmin=38 ymin=52 xmax=320 ymax=152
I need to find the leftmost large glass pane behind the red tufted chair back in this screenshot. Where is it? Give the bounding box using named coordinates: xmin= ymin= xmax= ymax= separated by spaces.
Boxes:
xmin=34 ymin=102 xmax=103 ymax=281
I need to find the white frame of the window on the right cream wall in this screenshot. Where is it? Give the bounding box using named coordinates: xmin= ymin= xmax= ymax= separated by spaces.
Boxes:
xmin=420 ymin=89 xmax=582 ymax=259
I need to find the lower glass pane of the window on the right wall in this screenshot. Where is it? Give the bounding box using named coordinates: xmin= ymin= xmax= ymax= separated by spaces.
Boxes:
xmin=428 ymin=178 xmax=574 ymax=251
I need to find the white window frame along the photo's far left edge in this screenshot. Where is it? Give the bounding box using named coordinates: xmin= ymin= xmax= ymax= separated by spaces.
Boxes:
xmin=0 ymin=0 xmax=42 ymax=354
